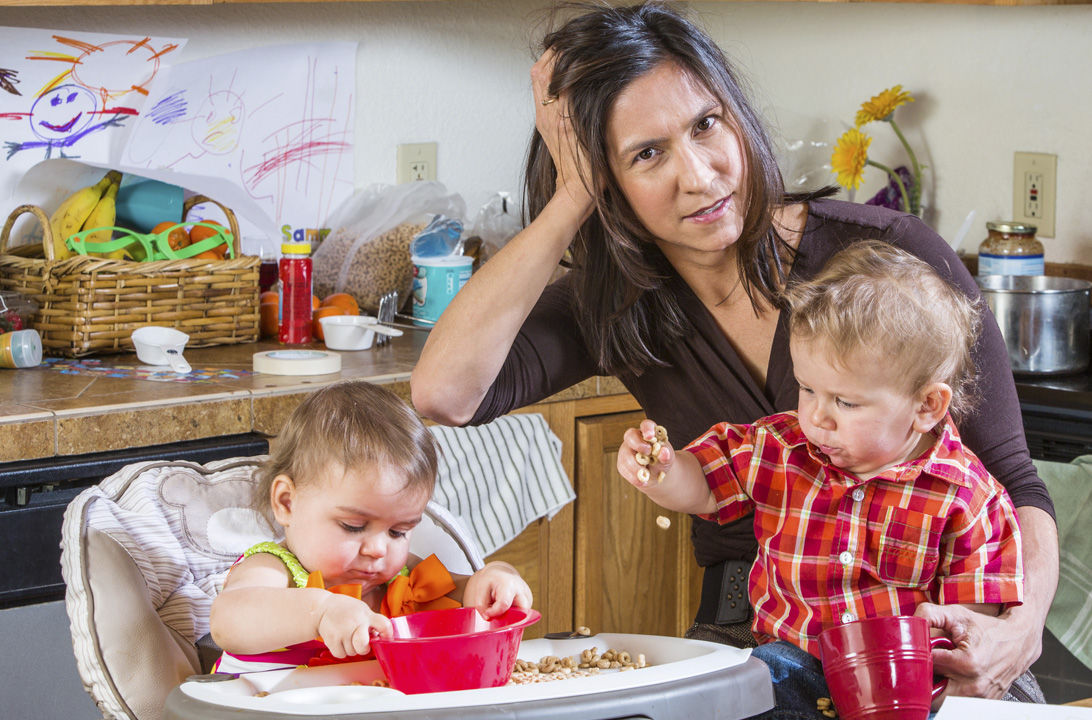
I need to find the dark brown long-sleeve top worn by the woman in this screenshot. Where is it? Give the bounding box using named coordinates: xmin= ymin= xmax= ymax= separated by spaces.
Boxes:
xmin=471 ymin=199 xmax=1054 ymax=566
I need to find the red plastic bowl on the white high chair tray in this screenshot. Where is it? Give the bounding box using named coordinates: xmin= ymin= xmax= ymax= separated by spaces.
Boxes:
xmin=371 ymin=607 xmax=542 ymax=694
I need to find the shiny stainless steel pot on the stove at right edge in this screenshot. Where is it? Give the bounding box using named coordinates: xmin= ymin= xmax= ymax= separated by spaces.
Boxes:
xmin=976 ymin=275 xmax=1092 ymax=375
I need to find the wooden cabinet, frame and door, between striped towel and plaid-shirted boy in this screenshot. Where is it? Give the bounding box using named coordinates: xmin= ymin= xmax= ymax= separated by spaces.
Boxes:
xmin=488 ymin=394 xmax=701 ymax=637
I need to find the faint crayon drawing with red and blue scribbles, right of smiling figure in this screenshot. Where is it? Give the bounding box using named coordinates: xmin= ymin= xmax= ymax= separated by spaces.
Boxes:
xmin=121 ymin=43 xmax=356 ymax=246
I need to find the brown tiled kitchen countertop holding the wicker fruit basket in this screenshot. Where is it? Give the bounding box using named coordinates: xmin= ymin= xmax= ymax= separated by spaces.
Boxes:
xmin=0 ymin=330 xmax=625 ymax=462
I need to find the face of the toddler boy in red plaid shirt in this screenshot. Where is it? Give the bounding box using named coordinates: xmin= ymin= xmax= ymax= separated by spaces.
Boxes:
xmin=790 ymin=339 xmax=929 ymax=479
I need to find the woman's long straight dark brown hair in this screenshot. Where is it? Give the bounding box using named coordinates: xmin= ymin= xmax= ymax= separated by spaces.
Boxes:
xmin=524 ymin=2 xmax=829 ymax=374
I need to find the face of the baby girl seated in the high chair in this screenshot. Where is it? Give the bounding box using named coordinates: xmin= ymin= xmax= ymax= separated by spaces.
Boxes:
xmin=282 ymin=463 xmax=428 ymax=592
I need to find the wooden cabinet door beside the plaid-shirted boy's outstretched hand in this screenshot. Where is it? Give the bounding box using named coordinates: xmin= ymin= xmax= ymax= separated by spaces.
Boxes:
xmin=573 ymin=412 xmax=701 ymax=637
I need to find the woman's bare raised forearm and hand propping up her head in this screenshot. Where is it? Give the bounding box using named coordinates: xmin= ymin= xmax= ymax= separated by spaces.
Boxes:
xmin=410 ymin=52 xmax=593 ymax=425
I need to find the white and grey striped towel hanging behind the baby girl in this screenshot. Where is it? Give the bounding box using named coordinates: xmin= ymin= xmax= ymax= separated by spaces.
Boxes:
xmin=429 ymin=413 xmax=577 ymax=556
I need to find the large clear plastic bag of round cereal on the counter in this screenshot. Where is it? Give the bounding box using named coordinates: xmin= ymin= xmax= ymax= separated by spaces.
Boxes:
xmin=312 ymin=181 xmax=466 ymax=312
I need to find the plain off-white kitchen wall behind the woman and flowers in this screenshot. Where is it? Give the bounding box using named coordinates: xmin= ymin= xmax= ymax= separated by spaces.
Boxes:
xmin=0 ymin=0 xmax=1092 ymax=262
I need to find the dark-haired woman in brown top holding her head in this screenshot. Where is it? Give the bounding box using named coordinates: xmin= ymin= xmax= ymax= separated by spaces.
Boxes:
xmin=412 ymin=3 xmax=1057 ymax=697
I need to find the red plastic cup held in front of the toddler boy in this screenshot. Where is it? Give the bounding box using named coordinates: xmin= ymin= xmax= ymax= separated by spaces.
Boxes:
xmin=819 ymin=615 xmax=954 ymax=720
